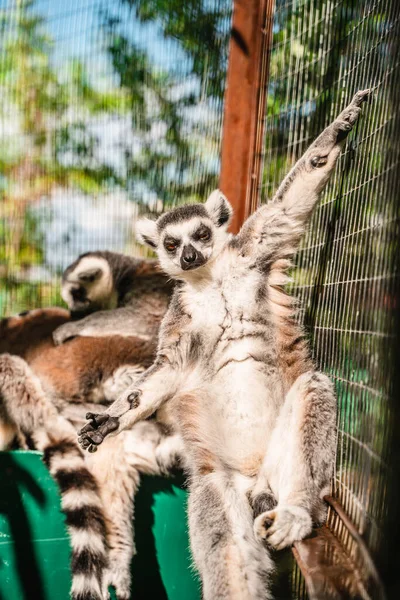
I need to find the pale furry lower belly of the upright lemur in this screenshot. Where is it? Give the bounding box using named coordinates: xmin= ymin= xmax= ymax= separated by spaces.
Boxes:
xmin=203 ymin=358 xmax=282 ymax=475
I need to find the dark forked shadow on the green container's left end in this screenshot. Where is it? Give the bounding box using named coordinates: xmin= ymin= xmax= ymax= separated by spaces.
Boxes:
xmin=0 ymin=453 xmax=45 ymax=600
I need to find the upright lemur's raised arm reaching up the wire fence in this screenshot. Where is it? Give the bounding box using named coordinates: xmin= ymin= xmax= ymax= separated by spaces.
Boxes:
xmin=238 ymin=90 xmax=370 ymax=262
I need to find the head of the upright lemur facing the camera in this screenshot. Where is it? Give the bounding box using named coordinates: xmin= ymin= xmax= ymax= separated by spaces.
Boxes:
xmin=137 ymin=190 xmax=232 ymax=279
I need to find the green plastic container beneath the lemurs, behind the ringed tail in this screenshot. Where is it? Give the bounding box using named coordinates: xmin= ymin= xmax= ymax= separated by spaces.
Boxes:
xmin=0 ymin=451 xmax=201 ymax=600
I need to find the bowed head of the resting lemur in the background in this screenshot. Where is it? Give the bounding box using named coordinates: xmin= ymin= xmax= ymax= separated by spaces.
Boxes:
xmin=61 ymin=255 xmax=117 ymax=314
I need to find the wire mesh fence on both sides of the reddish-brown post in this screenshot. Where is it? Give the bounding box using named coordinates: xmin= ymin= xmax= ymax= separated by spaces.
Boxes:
xmin=0 ymin=0 xmax=400 ymax=597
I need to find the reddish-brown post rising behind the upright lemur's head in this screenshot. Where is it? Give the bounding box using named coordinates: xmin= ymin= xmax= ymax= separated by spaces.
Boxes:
xmin=219 ymin=0 xmax=274 ymax=233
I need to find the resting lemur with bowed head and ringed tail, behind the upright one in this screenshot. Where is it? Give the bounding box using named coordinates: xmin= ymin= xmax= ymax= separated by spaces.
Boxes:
xmin=0 ymin=252 xmax=178 ymax=600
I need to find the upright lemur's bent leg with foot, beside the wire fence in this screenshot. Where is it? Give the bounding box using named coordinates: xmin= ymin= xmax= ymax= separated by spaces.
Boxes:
xmin=253 ymin=371 xmax=336 ymax=550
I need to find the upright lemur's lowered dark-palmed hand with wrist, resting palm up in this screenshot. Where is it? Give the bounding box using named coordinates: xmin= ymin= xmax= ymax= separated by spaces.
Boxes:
xmin=78 ymin=390 xmax=141 ymax=452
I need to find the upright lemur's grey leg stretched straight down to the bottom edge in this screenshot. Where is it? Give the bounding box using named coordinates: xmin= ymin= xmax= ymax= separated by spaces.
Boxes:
xmin=189 ymin=471 xmax=273 ymax=600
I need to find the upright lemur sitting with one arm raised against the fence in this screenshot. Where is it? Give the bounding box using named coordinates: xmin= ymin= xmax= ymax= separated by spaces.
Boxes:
xmin=76 ymin=90 xmax=369 ymax=600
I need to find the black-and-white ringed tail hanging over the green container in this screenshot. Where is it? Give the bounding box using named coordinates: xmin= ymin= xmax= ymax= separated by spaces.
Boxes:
xmin=0 ymin=354 xmax=107 ymax=600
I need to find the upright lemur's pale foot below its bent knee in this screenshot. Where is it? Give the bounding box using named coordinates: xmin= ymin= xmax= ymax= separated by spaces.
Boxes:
xmin=254 ymin=506 xmax=312 ymax=550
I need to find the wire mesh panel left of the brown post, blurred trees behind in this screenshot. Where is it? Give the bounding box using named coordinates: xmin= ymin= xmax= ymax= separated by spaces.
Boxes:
xmin=0 ymin=0 xmax=232 ymax=316
